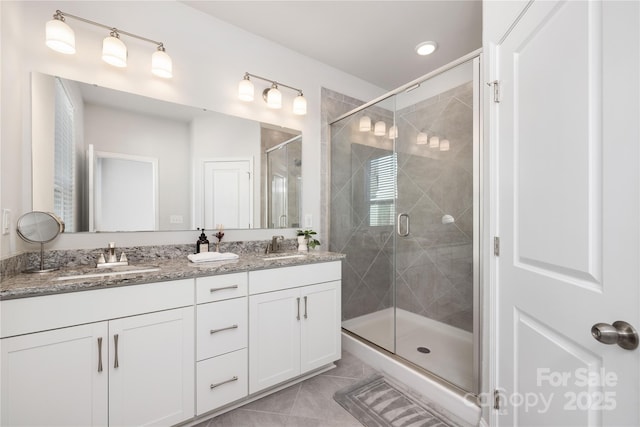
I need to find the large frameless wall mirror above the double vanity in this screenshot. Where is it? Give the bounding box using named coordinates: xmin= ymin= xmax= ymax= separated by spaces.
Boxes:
xmin=31 ymin=73 xmax=301 ymax=232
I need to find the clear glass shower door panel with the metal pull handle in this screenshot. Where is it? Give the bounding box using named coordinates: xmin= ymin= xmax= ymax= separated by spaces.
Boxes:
xmin=395 ymin=62 xmax=476 ymax=390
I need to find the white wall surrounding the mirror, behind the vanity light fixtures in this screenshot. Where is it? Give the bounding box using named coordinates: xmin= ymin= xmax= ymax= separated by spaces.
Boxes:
xmin=0 ymin=1 xmax=385 ymax=254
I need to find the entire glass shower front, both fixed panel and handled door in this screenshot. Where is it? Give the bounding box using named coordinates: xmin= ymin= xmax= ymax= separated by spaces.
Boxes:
xmin=329 ymin=56 xmax=479 ymax=392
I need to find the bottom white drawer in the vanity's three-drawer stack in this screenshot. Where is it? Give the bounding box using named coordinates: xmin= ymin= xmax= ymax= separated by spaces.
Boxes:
xmin=196 ymin=348 xmax=248 ymax=415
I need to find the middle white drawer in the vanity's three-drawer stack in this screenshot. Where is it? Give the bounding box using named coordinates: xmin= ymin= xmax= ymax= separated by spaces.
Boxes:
xmin=196 ymin=297 xmax=248 ymax=360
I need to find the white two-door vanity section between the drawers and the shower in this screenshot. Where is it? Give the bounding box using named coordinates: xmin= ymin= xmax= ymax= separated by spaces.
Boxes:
xmin=249 ymin=261 xmax=341 ymax=393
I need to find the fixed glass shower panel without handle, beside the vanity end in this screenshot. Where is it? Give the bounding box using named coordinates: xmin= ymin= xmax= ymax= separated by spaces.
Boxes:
xmin=330 ymin=99 xmax=396 ymax=352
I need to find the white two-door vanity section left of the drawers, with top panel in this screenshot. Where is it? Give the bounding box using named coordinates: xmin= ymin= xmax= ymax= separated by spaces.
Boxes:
xmin=0 ymin=279 xmax=194 ymax=426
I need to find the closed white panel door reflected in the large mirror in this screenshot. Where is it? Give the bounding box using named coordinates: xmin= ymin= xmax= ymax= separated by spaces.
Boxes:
xmin=203 ymin=160 xmax=253 ymax=230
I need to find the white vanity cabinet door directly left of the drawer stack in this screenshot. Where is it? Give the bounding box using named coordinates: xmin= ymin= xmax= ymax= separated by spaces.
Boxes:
xmin=109 ymin=307 xmax=195 ymax=426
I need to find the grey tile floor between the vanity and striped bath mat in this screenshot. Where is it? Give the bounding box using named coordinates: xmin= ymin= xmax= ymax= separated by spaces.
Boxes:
xmin=196 ymin=351 xmax=375 ymax=427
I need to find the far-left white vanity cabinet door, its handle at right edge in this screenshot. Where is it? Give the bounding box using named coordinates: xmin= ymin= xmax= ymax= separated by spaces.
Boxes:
xmin=1 ymin=322 xmax=109 ymax=426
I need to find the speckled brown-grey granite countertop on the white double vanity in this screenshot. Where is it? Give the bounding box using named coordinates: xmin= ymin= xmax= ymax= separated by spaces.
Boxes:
xmin=0 ymin=251 xmax=345 ymax=300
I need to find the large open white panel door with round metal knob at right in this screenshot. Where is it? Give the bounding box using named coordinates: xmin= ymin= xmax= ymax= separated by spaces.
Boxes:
xmin=492 ymin=1 xmax=640 ymax=426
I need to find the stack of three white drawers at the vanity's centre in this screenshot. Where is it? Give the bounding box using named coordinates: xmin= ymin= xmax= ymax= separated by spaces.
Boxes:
xmin=196 ymin=272 xmax=249 ymax=415
